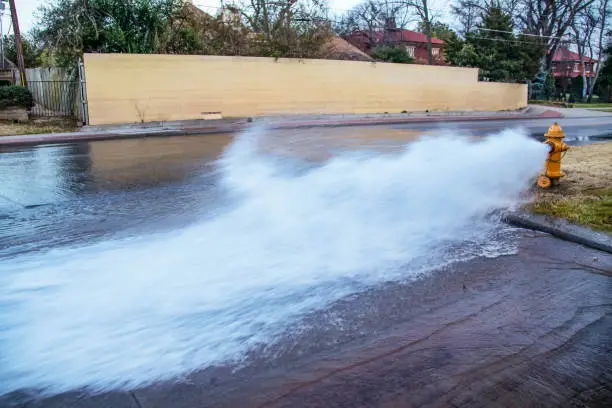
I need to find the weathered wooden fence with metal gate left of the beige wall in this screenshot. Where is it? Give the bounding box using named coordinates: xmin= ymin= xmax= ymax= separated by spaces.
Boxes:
xmin=27 ymin=81 xmax=80 ymax=118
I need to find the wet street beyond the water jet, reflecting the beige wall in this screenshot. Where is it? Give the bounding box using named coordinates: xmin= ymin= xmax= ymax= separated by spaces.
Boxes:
xmin=0 ymin=127 xmax=436 ymax=256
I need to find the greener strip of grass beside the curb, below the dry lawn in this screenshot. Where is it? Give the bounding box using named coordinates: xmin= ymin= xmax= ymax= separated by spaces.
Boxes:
xmin=529 ymin=188 xmax=612 ymax=233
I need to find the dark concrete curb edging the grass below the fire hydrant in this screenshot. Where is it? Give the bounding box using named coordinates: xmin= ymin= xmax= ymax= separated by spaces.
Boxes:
xmin=504 ymin=211 xmax=612 ymax=254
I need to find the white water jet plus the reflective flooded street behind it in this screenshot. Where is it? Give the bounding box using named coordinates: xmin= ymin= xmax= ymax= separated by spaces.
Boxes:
xmin=0 ymin=128 xmax=546 ymax=394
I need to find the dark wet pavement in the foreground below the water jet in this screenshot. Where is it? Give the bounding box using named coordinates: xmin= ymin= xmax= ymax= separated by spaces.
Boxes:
xmin=0 ymin=231 xmax=612 ymax=408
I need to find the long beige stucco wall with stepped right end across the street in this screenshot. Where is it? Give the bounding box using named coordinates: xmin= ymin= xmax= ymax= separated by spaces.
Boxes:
xmin=85 ymin=54 xmax=527 ymax=125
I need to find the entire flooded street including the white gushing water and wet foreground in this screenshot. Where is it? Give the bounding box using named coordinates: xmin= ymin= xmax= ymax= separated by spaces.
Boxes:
xmin=0 ymin=128 xmax=612 ymax=408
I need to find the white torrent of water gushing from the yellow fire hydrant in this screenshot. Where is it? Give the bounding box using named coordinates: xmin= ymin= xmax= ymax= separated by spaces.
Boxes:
xmin=0 ymin=129 xmax=546 ymax=395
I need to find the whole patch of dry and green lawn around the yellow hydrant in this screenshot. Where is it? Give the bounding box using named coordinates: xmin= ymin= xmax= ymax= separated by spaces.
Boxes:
xmin=527 ymin=142 xmax=612 ymax=233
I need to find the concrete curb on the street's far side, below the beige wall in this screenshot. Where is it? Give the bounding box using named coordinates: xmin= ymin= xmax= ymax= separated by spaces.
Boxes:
xmin=0 ymin=112 xmax=561 ymax=146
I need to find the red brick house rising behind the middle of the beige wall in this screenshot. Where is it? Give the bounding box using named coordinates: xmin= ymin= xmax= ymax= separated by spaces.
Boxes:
xmin=344 ymin=28 xmax=446 ymax=65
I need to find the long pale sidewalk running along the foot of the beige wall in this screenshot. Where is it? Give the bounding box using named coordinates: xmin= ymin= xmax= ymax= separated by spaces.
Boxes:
xmin=0 ymin=106 xmax=563 ymax=146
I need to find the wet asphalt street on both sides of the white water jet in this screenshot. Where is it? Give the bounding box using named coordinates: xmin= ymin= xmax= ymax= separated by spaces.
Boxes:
xmin=0 ymin=124 xmax=612 ymax=408
